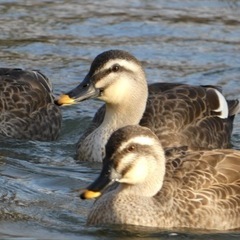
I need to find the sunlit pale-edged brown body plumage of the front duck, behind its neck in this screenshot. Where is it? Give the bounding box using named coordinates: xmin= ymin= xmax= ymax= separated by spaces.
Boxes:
xmin=155 ymin=150 xmax=240 ymax=229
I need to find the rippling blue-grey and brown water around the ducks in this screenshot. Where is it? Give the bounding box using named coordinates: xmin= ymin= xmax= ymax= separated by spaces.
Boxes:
xmin=0 ymin=0 xmax=240 ymax=240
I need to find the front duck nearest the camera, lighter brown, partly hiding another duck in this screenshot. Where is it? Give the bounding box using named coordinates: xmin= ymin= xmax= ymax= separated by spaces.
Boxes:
xmin=80 ymin=125 xmax=240 ymax=230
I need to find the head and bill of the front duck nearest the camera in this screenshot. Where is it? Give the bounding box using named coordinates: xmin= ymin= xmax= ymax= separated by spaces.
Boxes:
xmin=80 ymin=125 xmax=165 ymax=199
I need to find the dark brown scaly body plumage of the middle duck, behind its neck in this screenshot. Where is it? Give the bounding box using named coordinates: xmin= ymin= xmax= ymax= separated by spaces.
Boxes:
xmin=140 ymin=83 xmax=238 ymax=150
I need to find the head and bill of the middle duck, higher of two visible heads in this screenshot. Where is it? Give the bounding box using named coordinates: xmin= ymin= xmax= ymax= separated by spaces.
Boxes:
xmin=56 ymin=50 xmax=147 ymax=105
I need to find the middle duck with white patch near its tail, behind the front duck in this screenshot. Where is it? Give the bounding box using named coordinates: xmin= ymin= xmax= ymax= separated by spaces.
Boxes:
xmin=56 ymin=50 xmax=240 ymax=162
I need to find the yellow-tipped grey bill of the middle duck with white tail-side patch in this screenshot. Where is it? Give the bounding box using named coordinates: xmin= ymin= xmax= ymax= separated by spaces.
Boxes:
xmin=55 ymin=75 xmax=100 ymax=106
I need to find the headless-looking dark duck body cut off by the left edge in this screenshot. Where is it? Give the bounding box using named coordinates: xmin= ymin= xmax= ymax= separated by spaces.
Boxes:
xmin=0 ymin=68 xmax=62 ymax=141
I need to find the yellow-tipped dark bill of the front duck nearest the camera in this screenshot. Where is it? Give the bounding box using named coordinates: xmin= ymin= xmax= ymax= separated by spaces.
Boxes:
xmin=80 ymin=160 xmax=119 ymax=199
